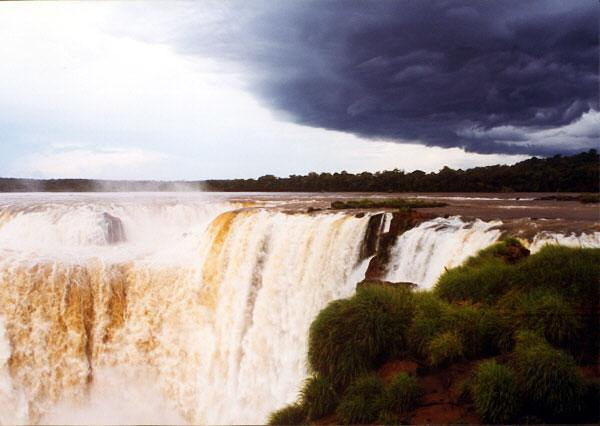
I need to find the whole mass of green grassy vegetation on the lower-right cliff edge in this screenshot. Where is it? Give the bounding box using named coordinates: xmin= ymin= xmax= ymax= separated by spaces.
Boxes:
xmin=268 ymin=238 xmax=600 ymax=424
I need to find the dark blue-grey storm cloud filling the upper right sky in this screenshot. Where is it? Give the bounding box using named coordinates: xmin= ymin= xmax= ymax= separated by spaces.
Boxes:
xmin=179 ymin=0 xmax=600 ymax=154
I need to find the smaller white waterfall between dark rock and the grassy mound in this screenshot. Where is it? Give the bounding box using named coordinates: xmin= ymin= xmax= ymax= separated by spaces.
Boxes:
xmin=385 ymin=216 xmax=501 ymax=288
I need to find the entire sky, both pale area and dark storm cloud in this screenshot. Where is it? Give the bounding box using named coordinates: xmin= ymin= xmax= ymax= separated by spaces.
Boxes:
xmin=0 ymin=0 xmax=600 ymax=180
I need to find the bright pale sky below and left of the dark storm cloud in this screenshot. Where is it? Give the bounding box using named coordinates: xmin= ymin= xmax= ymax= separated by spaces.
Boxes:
xmin=0 ymin=1 xmax=598 ymax=180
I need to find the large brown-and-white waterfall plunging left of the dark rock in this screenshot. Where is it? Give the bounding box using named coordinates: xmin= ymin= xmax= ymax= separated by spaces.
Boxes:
xmin=0 ymin=197 xmax=369 ymax=424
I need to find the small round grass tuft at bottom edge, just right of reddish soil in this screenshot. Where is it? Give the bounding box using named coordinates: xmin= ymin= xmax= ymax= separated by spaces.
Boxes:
xmin=470 ymin=360 xmax=520 ymax=424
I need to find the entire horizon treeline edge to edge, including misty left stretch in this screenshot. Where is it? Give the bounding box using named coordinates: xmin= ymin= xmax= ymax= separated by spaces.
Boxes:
xmin=0 ymin=149 xmax=600 ymax=192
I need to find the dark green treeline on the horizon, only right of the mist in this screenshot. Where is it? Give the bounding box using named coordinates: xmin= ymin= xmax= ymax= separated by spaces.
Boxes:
xmin=206 ymin=150 xmax=600 ymax=192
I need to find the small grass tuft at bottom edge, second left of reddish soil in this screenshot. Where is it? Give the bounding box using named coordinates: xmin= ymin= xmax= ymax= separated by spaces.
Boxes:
xmin=336 ymin=374 xmax=384 ymax=425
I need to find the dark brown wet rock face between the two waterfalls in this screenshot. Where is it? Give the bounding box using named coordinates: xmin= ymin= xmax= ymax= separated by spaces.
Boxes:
xmin=365 ymin=210 xmax=434 ymax=280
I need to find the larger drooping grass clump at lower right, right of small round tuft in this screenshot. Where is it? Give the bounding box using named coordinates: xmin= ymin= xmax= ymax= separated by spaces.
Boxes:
xmin=513 ymin=331 xmax=584 ymax=421
